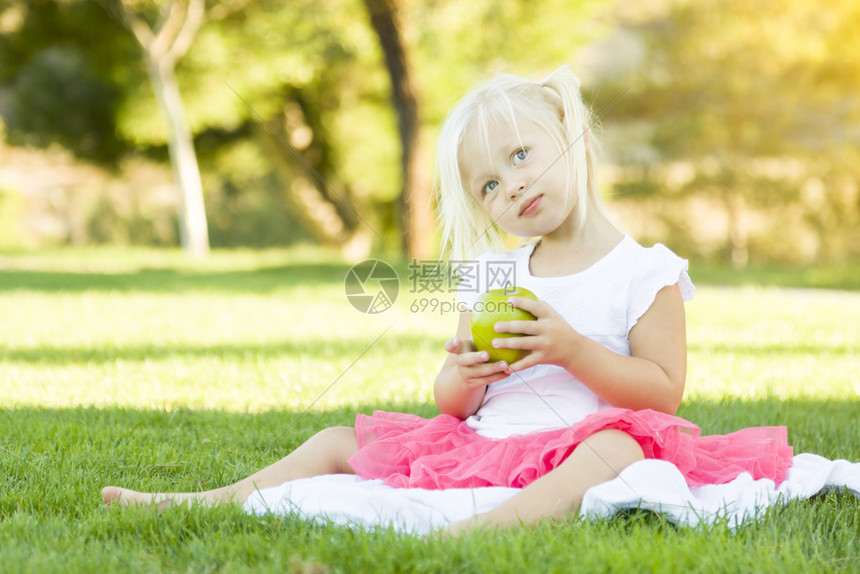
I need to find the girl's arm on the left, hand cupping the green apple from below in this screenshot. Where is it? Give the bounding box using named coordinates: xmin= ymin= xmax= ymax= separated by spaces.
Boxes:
xmin=433 ymin=311 xmax=511 ymax=419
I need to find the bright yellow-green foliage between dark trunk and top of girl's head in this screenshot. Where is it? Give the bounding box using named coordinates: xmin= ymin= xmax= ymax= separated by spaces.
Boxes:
xmin=402 ymin=0 xmax=608 ymax=122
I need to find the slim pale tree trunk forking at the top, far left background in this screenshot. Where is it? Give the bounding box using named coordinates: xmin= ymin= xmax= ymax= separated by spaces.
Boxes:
xmin=102 ymin=0 xmax=209 ymax=257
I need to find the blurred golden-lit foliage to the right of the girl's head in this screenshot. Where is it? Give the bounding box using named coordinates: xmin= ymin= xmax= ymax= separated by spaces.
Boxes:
xmin=601 ymin=0 xmax=860 ymax=265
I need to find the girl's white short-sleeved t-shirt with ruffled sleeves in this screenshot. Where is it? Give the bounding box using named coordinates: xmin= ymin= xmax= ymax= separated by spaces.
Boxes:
xmin=457 ymin=235 xmax=695 ymax=438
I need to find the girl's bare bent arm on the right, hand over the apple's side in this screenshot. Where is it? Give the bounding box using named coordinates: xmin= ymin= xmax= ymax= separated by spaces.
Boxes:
xmin=494 ymin=285 xmax=687 ymax=414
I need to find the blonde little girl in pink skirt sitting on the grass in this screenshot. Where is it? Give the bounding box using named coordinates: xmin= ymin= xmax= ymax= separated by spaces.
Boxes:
xmin=102 ymin=68 xmax=792 ymax=533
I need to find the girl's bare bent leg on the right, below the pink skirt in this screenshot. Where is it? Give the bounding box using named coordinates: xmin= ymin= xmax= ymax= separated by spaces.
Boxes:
xmin=445 ymin=430 xmax=644 ymax=536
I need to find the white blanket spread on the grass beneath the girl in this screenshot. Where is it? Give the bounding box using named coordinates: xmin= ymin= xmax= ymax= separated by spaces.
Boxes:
xmin=245 ymin=454 xmax=860 ymax=535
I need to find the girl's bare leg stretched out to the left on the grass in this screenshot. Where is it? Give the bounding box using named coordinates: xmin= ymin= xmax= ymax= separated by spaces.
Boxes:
xmin=102 ymin=427 xmax=358 ymax=508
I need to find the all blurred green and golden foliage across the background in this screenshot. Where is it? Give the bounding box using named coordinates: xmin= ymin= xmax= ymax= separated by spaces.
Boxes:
xmin=0 ymin=0 xmax=860 ymax=265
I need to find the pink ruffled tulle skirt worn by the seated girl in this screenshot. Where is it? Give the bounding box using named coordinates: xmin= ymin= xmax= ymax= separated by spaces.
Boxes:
xmin=349 ymin=408 xmax=793 ymax=490
